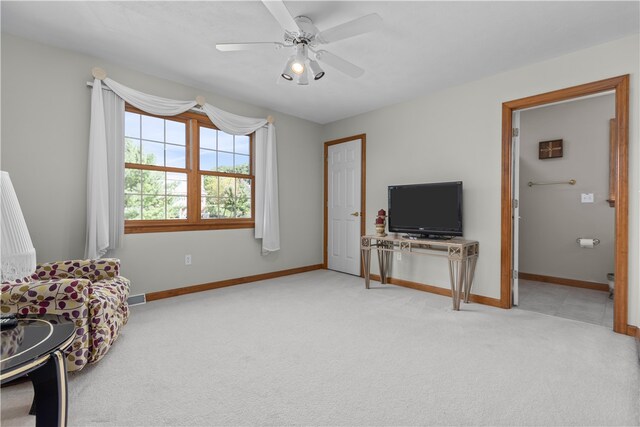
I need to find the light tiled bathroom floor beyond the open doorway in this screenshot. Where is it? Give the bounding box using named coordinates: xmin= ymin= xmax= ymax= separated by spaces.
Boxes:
xmin=518 ymin=279 xmax=613 ymax=328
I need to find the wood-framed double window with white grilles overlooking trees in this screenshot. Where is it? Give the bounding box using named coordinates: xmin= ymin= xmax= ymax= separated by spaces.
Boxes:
xmin=124 ymin=105 xmax=254 ymax=233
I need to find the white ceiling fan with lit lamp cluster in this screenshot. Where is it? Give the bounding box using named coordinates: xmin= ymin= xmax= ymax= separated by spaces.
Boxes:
xmin=216 ymin=0 xmax=382 ymax=85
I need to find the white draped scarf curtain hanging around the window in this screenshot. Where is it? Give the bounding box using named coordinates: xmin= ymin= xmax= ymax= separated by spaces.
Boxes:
xmin=85 ymin=78 xmax=280 ymax=258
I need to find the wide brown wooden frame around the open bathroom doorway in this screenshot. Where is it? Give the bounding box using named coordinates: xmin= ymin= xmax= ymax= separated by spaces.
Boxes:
xmin=500 ymin=74 xmax=634 ymax=334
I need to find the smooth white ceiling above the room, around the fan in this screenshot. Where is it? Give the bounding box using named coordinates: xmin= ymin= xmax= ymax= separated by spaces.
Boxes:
xmin=1 ymin=1 xmax=640 ymax=123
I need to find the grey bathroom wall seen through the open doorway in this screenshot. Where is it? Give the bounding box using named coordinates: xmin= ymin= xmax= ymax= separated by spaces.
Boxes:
xmin=519 ymin=94 xmax=615 ymax=283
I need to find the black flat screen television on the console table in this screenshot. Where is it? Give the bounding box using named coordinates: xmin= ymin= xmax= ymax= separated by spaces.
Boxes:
xmin=389 ymin=181 xmax=462 ymax=238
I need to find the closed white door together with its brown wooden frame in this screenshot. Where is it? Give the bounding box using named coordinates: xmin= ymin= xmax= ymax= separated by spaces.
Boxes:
xmin=323 ymin=134 xmax=366 ymax=276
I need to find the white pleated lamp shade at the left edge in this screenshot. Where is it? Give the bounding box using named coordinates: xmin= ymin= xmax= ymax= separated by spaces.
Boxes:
xmin=0 ymin=171 xmax=36 ymax=282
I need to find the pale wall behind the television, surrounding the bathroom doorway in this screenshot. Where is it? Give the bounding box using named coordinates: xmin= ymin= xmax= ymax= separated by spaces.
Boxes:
xmin=323 ymin=35 xmax=640 ymax=325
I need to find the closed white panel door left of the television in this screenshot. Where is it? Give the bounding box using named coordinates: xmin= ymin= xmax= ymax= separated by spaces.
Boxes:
xmin=327 ymin=139 xmax=362 ymax=275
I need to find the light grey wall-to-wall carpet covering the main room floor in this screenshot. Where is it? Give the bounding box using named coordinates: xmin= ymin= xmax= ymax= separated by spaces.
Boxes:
xmin=1 ymin=270 xmax=640 ymax=426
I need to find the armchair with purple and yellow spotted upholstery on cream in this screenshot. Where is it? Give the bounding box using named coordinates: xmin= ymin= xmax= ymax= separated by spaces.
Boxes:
xmin=0 ymin=258 xmax=129 ymax=371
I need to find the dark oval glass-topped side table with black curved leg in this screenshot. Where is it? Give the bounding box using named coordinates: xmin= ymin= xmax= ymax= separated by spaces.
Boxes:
xmin=0 ymin=315 xmax=75 ymax=427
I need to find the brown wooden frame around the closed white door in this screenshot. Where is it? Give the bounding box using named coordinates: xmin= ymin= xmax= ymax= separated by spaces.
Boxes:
xmin=322 ymin=133 xmax=367 ymax=277
